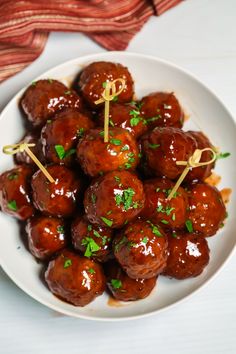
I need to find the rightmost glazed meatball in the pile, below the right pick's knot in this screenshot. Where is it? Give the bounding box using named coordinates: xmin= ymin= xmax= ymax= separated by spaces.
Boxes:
xmin=189 ymin=183 xmax=226 ymax=236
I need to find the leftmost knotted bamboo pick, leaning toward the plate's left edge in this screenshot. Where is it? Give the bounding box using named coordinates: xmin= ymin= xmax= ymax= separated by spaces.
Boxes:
xmin=2 ymin=142 xmax=55 ymax=183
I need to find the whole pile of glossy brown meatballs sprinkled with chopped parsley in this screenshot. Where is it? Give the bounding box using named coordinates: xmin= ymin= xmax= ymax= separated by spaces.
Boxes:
xmin=0 ymin=61 xmax=229 ymax=306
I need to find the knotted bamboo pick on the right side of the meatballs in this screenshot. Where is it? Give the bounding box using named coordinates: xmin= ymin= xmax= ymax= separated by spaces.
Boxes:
xmin=167 ymin=148 xmax=217 ymax=200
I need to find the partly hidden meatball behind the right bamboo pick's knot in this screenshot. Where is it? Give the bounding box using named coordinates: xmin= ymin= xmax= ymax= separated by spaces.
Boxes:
xmin=186 ymin=131 xmax=215 ymax=181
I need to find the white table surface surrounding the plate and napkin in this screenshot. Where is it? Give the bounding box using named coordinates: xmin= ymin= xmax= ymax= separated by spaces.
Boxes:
xmin=0 ymin=0 xmax=236 ymax=354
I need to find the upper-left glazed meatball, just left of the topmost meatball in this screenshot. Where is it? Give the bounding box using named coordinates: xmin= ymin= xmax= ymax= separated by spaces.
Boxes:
xmin=21 ymin=79 xmax=82 ymax=127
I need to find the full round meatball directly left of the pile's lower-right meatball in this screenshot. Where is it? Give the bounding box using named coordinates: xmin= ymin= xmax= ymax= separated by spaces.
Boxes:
xmin=113 ymin=220 xmax=168 ymax=279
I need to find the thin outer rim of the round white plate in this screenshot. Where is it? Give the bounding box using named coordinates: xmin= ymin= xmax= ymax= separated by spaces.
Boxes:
xmin=0 ymin=51 xmax=236 ymax=322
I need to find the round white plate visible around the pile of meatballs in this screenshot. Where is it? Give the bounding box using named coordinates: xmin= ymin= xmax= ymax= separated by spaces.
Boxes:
xmin=0 ymin=52 xmax=236 ymax=320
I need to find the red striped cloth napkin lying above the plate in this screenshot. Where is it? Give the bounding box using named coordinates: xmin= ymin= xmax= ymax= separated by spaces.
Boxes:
xmin=0 ymin=0 xmax=182 ymax=82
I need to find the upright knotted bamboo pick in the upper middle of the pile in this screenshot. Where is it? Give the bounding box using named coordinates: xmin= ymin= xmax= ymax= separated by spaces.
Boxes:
xmin=94 ymin=78 xmax=126 ymax=143
